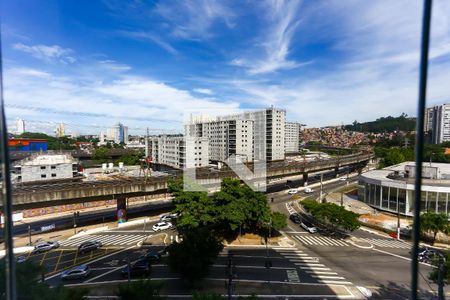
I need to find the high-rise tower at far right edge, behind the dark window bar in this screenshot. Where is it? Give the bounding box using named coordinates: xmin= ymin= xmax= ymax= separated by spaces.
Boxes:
xmin=425 ymin=104 xmax=450 ymax=144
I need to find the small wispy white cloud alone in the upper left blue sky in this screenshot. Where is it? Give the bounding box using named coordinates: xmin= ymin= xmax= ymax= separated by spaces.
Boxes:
xmin=13 ymin=43 xmax=76 ymax=64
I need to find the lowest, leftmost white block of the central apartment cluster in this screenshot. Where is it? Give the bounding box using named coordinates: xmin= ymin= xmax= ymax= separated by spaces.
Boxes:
xmin=145 ymin=135 xmax=209 ymax=169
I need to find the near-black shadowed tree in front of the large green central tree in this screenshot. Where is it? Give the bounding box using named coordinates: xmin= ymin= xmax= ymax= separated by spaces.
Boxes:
xmin=167 ymin=227 xmax=223 ymax=284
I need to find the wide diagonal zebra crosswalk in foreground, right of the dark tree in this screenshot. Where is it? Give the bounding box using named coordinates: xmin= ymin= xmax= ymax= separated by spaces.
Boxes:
xmin=276 ymin=248 xmax=353 ymax=285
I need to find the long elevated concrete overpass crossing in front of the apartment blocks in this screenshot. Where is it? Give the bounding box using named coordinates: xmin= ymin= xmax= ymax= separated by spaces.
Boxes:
xmin=5 ymin=153 xmax=373 ymax=210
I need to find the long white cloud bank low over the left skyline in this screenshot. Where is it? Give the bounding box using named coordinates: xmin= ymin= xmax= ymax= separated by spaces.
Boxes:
xmin=5 ymin=68 xmax=239 ymax=133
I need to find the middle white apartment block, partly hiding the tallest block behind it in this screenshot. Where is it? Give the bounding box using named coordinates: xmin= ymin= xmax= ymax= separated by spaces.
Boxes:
xmin=186 ymin=118 xmax=253 ymax=162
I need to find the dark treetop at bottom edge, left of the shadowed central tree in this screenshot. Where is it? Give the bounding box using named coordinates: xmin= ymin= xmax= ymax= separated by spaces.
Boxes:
xmin=116 ymin=280 xmax=165 ymax=300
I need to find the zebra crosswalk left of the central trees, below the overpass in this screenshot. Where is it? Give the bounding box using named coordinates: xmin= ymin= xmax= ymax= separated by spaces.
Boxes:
xmin=60 ymin=234 xmax=148 ymax=247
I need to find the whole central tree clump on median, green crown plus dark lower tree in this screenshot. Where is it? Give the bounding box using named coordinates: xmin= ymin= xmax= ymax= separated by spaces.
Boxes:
xmin=168 ymin=178 xmax=286 ymax=282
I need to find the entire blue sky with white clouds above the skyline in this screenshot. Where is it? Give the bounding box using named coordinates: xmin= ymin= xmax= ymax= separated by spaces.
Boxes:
xmin=1 ymin=0 xmax=450 ymax=133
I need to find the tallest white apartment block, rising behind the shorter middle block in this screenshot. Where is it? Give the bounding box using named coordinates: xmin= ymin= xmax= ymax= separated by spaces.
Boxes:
xmin=217 ymin=107 xmax=286 ymax=161
